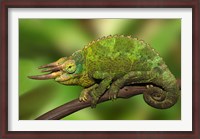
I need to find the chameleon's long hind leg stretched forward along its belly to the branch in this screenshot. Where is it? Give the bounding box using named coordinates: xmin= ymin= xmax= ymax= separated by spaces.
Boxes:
xmin=108 ymin=71 xmax=157 ymax=99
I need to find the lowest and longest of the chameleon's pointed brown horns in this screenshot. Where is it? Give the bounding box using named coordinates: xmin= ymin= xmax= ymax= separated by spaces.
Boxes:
xmin=28 ymin=71 xmax=61 ymax=80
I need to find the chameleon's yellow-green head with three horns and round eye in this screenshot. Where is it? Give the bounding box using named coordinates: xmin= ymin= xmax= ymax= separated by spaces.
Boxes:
xmin=28 ymin=54 xmax=82 ymax=85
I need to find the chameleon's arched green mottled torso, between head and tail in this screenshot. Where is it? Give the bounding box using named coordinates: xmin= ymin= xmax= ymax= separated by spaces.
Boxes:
xmin=84 ymin=36 xmax=164 ymax=75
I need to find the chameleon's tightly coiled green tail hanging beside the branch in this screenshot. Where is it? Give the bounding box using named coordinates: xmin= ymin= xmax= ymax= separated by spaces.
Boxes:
xmin=144 ymin=72 xmax=180 ymax=109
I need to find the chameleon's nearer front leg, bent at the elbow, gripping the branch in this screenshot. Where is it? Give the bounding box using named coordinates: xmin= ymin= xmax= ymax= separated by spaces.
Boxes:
xmin=90 ymin=71 xmax=113 ymax=108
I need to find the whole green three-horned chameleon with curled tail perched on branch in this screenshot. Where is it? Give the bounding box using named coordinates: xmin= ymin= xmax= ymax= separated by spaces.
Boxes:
xmin=29 ymin=35 xmax=180 ymax=109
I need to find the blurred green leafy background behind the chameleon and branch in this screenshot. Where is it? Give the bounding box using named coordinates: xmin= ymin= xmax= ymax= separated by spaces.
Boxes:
xmin=19 ymin=19 xmax=181 ymax=120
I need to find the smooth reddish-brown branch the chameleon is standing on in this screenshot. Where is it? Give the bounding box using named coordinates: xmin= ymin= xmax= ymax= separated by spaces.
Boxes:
xmin=36 ymin=80 xmax=181 ymax=120
